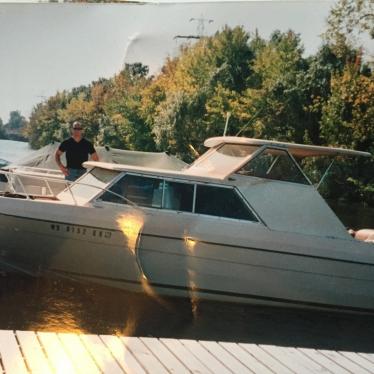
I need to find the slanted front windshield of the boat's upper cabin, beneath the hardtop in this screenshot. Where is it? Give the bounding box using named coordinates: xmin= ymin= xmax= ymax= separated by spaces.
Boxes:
xmin=189 ymin=144 xmax=259 ymax=176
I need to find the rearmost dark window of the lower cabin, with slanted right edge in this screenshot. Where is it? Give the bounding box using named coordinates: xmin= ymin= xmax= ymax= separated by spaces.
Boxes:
xmin=195 ymin=185 xmax=258 ymax=221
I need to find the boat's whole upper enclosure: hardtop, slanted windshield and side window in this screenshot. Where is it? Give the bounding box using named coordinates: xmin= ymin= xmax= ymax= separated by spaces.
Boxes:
xmin=185 ymin=136 xmax=371 ymax=184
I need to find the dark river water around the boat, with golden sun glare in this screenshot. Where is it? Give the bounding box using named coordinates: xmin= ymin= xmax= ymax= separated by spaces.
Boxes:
xmin=0 ymin=140 xmax=374 ymax=352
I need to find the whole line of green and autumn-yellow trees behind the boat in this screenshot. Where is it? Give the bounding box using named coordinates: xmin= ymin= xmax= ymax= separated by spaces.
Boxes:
xmin=0 ymin=0 xmax=374 ymax=205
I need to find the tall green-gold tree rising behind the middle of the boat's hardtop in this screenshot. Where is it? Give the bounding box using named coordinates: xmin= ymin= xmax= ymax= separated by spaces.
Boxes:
xmin=243 ymin=31 xmax=308 ymax=142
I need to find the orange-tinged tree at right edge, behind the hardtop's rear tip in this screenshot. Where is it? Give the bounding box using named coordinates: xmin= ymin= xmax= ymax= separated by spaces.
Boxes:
xmin=321 ymin=64 xmax=374 ymax=205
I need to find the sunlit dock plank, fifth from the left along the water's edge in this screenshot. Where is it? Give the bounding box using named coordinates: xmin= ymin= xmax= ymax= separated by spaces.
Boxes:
xmin=79 ymin=335 xmax=124 ymax=374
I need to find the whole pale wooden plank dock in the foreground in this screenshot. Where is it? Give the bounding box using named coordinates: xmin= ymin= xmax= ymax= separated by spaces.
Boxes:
xmin=0 ymin=330 xmax=374 ymax=374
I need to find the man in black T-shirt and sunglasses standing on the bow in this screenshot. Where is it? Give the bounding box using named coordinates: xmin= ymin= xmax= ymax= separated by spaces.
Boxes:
xmin=55 ymin=121 xmax=99 ymax=182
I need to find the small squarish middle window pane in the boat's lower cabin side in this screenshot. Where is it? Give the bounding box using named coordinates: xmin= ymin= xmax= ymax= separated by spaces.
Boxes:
xmin=163 ymin=181 xmax=194 ymax=212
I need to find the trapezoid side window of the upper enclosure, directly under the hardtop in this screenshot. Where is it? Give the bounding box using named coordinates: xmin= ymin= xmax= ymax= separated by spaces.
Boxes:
xmin=237 ymin=148 xmax=309 ymax=184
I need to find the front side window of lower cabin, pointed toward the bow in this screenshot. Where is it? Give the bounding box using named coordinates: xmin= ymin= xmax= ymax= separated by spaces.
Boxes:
xmin=101 ymin=175 xmax=163 ymax=208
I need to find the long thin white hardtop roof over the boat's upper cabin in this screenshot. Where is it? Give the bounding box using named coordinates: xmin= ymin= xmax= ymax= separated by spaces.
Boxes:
xmin=204 ymin=136 xmax=371 ymax=157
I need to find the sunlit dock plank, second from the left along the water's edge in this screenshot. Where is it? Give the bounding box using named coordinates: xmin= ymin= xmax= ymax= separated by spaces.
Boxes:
xmin=16 ymin=331 xmax=52 ymax=374
